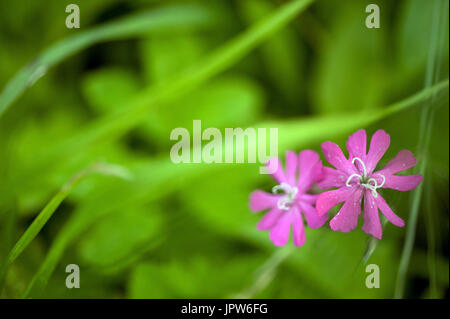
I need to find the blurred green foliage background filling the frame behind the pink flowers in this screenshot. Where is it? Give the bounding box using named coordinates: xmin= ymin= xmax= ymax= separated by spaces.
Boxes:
xmin=0 ymin=0 xmax=449 ymax=298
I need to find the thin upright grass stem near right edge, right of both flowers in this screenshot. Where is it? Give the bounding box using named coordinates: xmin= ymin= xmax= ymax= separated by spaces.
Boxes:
xmin=394 ymin=1 xmax=448 ymax=298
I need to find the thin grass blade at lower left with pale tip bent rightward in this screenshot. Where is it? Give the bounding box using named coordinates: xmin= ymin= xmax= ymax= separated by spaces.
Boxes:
xmin=0 ymin=162 xmax=130 ymax=291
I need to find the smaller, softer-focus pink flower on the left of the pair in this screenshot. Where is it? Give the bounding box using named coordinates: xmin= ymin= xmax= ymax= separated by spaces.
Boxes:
xmin=250 ymin=150 xmax=328 ymax=246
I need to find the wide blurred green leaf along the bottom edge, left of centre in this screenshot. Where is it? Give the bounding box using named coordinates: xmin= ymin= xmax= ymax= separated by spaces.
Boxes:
xmin=128 ymin=255 xmax=262 ymax=298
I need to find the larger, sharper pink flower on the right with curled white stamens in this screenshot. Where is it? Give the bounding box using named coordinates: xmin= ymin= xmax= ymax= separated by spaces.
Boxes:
xmin=316 ymin=130 xmax=423 ymax=239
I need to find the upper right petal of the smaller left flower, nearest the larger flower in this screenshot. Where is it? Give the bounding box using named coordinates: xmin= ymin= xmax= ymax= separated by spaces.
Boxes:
xmin=298 ymin=150 xmax=322 ymax=191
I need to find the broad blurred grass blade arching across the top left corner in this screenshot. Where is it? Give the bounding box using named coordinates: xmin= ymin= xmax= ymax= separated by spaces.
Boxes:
xmin=0 ymin=5 xmax=214 ymax=117
